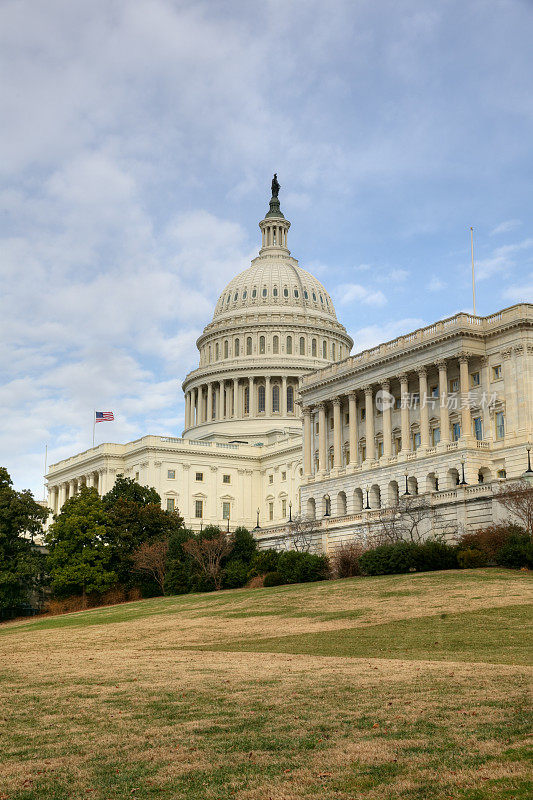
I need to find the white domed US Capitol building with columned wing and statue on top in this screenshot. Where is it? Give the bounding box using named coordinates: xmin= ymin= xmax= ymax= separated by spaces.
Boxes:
xmin=46 ymin=176 xmax=533 ymax=551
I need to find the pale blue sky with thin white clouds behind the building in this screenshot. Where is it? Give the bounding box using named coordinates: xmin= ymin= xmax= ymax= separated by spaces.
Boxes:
xmin=0 ymin=0 xmax=533 ymax=498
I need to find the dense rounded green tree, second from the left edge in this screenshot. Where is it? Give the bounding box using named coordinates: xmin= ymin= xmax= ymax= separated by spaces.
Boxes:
xmin=45 ymin=487 xmax=118 ymax=597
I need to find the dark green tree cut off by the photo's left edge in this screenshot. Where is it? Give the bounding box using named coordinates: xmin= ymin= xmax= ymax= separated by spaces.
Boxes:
xmin=0 ymin=467 xmax=48 ymax=609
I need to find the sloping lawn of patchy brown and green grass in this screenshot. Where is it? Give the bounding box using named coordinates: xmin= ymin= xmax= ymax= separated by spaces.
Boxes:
xmin=0 ymin=569 xmax=533 ymax=800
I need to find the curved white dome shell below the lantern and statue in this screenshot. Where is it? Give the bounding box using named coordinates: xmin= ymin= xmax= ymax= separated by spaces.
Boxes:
xmin=213 ymin=256 xmax=337 ymax=321
